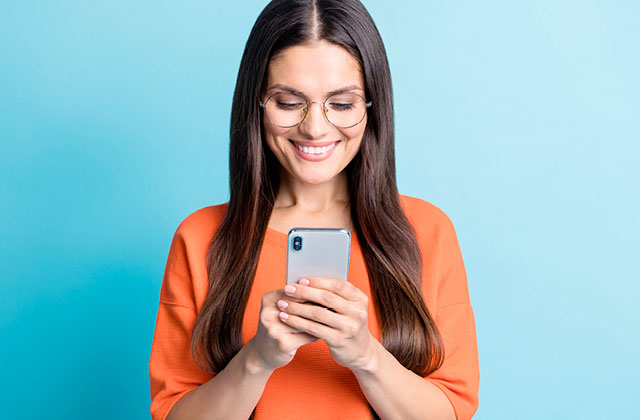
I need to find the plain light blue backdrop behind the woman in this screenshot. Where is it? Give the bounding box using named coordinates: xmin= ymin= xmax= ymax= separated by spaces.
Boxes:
xmin=0 ymin=0 xmax=640 ymax=420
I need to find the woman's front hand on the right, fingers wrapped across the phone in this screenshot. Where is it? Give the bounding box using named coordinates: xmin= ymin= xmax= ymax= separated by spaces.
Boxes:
xmin=277 ymin=277 xmax=378 ymax=370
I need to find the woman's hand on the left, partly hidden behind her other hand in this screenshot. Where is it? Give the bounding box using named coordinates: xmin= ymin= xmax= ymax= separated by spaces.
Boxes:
xmin=247 ymin=289 xmax=318 ymax=372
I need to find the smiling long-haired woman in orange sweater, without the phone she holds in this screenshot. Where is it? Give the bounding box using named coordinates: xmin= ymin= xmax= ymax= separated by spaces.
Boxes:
xmin=150 ymin=0 xmax=479 ymax=420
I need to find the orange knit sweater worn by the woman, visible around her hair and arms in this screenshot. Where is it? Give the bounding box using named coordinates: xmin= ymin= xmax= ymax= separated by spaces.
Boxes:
xmin=149 ymin=196 xmax=479 ymax=420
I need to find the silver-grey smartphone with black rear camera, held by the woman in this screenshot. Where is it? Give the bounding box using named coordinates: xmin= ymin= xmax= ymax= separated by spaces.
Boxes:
xmin=287 ymin=228 xmax=351 ymax=284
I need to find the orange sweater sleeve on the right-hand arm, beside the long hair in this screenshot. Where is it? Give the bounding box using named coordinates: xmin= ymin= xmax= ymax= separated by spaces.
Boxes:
xmin=427 ymin=213 xmax=480 ymax=420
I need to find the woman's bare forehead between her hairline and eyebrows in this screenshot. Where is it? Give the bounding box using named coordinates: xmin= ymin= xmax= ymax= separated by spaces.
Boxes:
xmin=267 ymin=41 xmax=365 ymax=95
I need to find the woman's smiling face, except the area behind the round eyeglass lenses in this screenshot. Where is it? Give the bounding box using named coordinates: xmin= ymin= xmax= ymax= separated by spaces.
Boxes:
xmin=261 ymin=41 xmax=367 ymax=184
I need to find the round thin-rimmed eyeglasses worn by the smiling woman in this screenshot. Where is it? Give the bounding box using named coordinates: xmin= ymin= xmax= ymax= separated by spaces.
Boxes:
xmin=260 ymin=92 xmax=372 ymax=128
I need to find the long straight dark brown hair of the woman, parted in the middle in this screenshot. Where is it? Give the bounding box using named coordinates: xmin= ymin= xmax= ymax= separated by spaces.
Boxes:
xmin=191 ymin=0 xmax=444 ymax=384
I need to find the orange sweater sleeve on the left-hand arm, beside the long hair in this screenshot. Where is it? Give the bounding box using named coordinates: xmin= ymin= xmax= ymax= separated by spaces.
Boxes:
xmin=149 ymin=221 xmax=212 ymax=420
